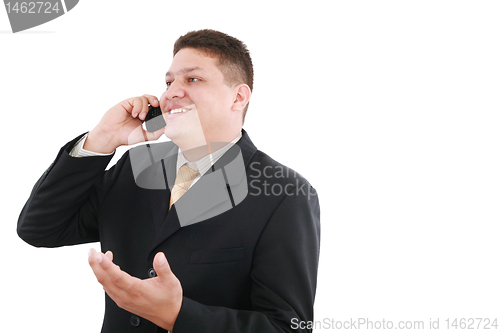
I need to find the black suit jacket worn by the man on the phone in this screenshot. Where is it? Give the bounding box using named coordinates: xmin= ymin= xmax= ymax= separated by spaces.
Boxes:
xmin=17 ymin=131 xmax=320 ymax=333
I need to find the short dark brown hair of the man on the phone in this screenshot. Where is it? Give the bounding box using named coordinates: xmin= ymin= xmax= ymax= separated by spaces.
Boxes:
xmin=174 ymin=29 xmax=253 ymax=121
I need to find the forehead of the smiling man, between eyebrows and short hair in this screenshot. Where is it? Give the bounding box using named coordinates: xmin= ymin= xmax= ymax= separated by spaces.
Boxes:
xmin=166 ymin=48 xmax=222 ymax=76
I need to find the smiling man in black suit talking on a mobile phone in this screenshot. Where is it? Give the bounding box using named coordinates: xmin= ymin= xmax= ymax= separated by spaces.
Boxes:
xmin=18 ymin=30 xmax=319 ymax=333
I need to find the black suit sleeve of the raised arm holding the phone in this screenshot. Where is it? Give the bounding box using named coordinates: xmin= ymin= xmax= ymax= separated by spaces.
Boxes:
xmin=17 ymin=136 xmax=116 ymax=247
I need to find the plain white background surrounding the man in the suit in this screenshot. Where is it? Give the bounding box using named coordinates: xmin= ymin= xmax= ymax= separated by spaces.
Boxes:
xmin=0 ymin=0 xmax=500 ymax=332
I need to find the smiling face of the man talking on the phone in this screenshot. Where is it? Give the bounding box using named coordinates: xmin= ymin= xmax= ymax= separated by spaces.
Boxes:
xmin=160 ymin=48 xmax=235 ymax=142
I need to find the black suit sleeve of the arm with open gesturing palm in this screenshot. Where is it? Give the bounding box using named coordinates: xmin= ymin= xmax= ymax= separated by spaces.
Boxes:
xmin=172 ymin=184 xmax=320 ymax=333
